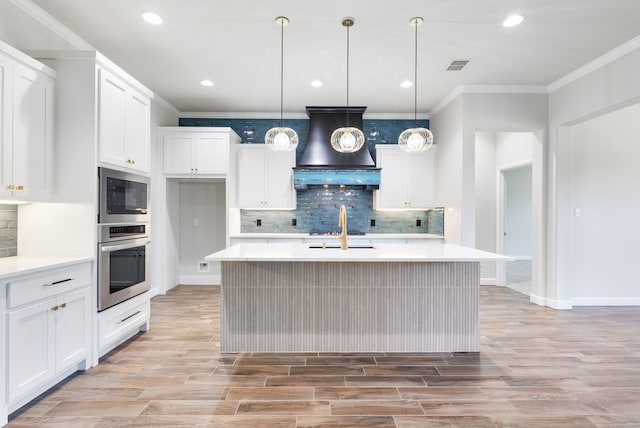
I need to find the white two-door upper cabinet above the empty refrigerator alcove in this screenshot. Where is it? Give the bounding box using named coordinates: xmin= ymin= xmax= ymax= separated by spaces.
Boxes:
xmin=163 ymin=128 xmax=235 ymax=177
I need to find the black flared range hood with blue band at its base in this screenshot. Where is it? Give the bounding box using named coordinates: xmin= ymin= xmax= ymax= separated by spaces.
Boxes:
xmin=293 ymin=107 xmax=380 ymax=189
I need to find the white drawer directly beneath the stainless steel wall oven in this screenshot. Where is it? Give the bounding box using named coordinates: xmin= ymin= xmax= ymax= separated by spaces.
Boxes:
xmin=98 ymin=293 xmax=150 ymax=349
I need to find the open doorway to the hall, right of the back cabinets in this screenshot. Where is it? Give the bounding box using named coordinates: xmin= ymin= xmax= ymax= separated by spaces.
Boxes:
xmin=475 ymin=131 xmax=542 ymax=295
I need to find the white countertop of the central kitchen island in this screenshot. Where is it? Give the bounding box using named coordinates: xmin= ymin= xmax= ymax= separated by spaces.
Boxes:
xmin=205 ymin=241 xmax=512 ymax=262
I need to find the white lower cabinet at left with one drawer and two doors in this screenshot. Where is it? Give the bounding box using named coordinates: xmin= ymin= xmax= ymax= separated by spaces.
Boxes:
xmin=2 ymin=262 xmax=93 ymax=411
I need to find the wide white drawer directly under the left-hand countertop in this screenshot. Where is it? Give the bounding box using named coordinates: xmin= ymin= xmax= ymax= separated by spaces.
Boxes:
xmin=7 ymin=263 xmax=91 ymax=309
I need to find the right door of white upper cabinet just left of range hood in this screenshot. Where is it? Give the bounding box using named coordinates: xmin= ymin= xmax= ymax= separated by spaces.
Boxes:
xmin=264 ymin=149 xmax=296 ymax=208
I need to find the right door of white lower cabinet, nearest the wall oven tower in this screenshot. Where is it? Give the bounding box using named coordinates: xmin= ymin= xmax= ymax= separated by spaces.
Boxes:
xmin=56 ymin=288 xmax=89 ymax=371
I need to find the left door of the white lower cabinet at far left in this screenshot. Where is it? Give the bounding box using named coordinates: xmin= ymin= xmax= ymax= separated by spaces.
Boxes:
xmin=8 ymin=299 xmax=59 ymax=401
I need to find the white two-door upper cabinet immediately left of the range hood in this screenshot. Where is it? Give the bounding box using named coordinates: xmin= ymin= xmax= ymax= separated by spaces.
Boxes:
xmin=237 ymin=144 xmax=296 ymax=209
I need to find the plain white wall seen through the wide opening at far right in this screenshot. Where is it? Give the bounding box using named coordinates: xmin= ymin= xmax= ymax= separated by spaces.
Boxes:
xmin=570 ymin=104 xmax=640 ymax=305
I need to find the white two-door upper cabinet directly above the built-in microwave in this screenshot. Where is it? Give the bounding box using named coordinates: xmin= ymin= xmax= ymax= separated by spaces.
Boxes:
xmin=98 ymin=68 xmax=151 ymax=172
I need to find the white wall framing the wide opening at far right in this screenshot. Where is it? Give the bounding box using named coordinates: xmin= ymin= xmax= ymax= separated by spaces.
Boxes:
xmin=540 ymin=38 xmax=640 ymax=308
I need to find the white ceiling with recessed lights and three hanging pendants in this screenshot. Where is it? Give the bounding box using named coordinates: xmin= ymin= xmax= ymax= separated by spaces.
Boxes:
xmin=23 ymin=0 xmax=640 ymax=116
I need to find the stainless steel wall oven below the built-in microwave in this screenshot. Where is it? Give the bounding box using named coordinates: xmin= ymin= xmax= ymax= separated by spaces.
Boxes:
xmin=98 ymin=223 xmax=151 ymax=312
